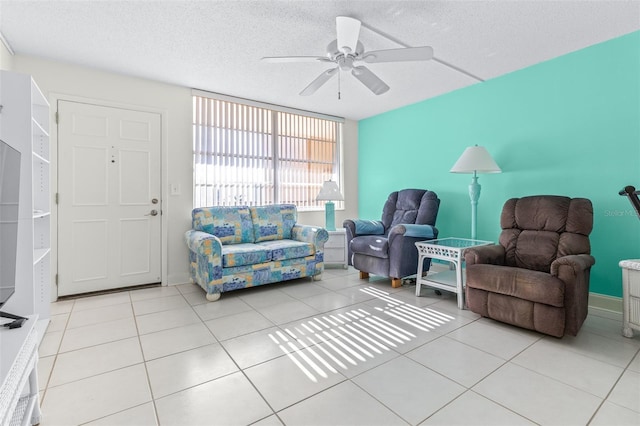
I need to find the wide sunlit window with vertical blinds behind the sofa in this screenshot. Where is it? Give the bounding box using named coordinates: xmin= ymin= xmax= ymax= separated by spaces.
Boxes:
xmin=193 ymin=91 xmax=342 ymax=210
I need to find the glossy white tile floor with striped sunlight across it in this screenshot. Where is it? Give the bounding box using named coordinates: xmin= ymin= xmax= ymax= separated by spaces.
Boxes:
xmin=39 ymin=269 xmax=640 ymax=426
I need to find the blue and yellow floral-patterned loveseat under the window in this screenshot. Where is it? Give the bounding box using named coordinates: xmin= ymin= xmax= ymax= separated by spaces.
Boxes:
xmin=185 ymin=204 xmax=329 ymax=301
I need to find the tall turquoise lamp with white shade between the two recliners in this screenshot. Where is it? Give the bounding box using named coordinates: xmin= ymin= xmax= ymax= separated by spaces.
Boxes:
xmin=450 ymin=145 xmax=502 ymax=240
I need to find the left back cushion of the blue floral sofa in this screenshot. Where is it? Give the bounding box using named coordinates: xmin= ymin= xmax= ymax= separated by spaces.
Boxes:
xmin=191 ymin=206 xmax=254 ymax=244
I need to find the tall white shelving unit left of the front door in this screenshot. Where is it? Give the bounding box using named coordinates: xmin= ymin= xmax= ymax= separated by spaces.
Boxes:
xmin=0 ymin=71 xmax=51 ymax=335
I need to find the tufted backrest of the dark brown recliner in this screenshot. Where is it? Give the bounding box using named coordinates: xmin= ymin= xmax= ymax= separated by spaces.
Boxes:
xmin=500 ymin=195 xmax=593 ymax=272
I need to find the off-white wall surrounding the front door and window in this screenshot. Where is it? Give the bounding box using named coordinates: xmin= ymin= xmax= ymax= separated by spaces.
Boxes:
xmin=11 ymin=55 xmax=358 ymax=292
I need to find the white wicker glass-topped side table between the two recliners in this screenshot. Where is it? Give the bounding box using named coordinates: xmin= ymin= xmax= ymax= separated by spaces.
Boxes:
xmin=416 ymin=237 xmax=493 ymax=309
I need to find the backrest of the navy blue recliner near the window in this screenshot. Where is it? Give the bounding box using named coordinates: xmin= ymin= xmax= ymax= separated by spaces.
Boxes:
xmin=381 ymin=189 xmax=440 ymax=234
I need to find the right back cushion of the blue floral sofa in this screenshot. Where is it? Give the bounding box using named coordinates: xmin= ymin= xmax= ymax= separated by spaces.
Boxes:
xmin=250 ymin=204 xmax=297 ymax=243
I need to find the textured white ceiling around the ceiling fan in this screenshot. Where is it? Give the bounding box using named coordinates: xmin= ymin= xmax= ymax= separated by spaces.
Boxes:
xmin=0 ymin=0 xmax=640 ymax=120
